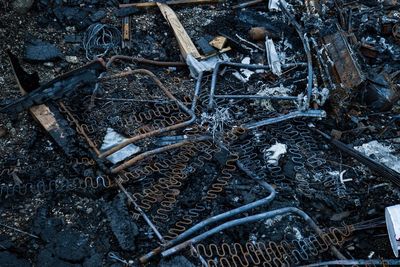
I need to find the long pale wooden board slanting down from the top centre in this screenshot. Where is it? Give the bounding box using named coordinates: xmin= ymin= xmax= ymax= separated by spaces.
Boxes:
xmin=157 ymin=3 xmax=201 ymax=60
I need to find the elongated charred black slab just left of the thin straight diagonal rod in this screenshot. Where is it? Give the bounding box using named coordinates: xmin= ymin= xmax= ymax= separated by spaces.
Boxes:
xmin=105 ymin=194 xmax=139 ymax=251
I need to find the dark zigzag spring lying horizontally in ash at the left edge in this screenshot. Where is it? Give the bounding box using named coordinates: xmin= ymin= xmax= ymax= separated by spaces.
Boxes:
xmin=0 ymin=176 xmax=112 ymax=197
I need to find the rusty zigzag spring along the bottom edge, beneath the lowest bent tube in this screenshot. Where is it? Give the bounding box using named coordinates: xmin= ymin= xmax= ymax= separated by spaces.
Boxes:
xmin=196 ymin=226 xmax=354 ymax=267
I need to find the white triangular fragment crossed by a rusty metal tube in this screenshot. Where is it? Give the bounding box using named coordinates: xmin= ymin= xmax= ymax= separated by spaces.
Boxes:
xmin=100 ymin=128 xmax=140 ymax=164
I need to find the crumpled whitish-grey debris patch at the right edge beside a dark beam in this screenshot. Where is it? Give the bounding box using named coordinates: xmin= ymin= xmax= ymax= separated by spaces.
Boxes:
xmin=354 ymin=140 xmax=400 ymax=173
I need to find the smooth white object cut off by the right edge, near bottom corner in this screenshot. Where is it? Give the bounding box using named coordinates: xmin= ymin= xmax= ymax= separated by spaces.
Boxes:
xmin=385 ymin=204 xmax=400 ymax=257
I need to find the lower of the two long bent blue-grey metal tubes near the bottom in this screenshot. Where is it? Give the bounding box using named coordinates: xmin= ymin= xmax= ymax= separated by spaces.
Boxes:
xmin=161 ymin=207 xmax=346 ymax=260
